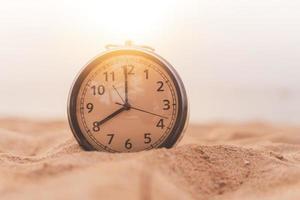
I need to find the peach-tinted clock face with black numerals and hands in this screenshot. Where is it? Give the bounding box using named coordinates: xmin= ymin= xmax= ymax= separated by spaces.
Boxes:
xmin=72 ymin=49 xmax=183 ymax=152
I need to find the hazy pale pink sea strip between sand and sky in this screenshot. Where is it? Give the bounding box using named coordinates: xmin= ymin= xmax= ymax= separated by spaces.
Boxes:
xmin=0 ymin=80 xmax=300 ymax=124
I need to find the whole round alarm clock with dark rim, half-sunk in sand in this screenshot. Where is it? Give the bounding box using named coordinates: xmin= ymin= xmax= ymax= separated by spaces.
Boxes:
xmin=68 ymin=42 xmax=188 ymax=152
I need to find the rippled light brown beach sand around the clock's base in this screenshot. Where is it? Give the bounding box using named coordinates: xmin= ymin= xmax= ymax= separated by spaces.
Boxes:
xmin=0 ymin=119 xmax=300 ymax=200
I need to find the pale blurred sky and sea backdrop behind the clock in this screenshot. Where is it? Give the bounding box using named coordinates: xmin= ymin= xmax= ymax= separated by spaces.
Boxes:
xmin=0 ymin=0 xmax=300 ymax=124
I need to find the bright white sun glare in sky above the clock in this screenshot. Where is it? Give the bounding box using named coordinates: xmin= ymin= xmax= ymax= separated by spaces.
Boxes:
xmin=63 ymin=0 xmax=176 ymax=40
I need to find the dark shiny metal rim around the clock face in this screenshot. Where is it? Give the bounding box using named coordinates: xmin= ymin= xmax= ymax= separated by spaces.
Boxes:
xmin=67 ymin=47 xmax=189 ymax=151
